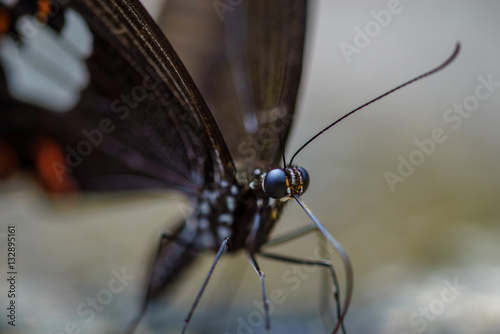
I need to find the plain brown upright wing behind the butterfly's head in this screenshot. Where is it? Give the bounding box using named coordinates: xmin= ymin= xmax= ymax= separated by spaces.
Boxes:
xmin=156 ymin=0 xmax=306 ymax=171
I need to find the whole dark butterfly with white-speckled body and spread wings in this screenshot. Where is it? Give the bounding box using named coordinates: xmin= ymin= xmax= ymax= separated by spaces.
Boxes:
xmin=0 ymin=0 xmax=458 ymax=333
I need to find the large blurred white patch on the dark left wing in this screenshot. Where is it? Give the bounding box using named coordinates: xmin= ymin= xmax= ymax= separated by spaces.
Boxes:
xmin=0 ymin=10 xmax=92 ymax=112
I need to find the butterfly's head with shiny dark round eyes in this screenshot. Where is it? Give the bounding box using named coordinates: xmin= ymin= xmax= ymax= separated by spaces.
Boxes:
xmin=262 ymin=166 xmax=309 ymax=201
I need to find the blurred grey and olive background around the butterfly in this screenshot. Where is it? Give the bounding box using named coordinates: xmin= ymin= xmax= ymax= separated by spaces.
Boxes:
xmin=0 ymin=0 xmax=500 ymax=334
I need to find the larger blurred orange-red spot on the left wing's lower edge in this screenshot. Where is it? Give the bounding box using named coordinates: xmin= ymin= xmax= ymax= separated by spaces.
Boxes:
xmin=33 ymin=137 xmax=78 ymax=194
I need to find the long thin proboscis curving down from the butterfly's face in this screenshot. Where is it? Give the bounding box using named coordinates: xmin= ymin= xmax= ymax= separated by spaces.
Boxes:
xmin=293 ymin=194 xmax=354 ymax=334
